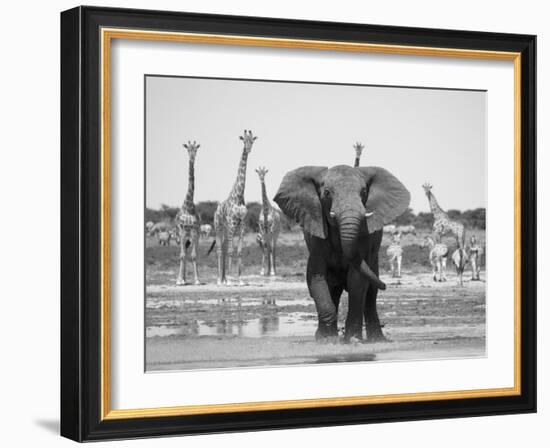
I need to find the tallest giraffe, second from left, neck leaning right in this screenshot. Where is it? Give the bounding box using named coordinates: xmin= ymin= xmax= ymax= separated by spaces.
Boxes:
xmin=215 ymin=130 xmax=258 ymax=285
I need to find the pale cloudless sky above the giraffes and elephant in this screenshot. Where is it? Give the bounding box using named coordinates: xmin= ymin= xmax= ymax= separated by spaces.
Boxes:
xmin=145 ymin=76 xmax=487 ymax=212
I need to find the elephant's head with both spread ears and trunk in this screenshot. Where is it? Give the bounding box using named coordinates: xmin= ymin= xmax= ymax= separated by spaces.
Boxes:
xmin=274 ymin=165 xmax=410 ymax=289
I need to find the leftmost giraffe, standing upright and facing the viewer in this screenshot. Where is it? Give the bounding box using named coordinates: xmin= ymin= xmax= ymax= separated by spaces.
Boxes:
xmin=176 ymin=141 xmax=201 ymax=286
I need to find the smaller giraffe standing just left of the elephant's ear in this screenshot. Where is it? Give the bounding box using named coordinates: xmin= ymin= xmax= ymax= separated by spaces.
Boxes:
xmin=256 ymin=167 xmax=281 ymax=277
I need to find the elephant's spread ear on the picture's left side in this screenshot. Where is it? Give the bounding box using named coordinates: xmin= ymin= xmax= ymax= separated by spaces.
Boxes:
xmin=273 ymin=166 xmax=327 ymax=239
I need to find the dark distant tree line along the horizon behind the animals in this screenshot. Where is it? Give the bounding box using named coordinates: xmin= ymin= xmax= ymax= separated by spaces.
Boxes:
xmin=145 ymin=201 xmax=485 ymax=232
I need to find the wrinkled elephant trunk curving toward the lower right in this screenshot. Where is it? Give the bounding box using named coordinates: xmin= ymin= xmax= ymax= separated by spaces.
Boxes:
xmin=339 ymin=213 xmax=386 ymax=290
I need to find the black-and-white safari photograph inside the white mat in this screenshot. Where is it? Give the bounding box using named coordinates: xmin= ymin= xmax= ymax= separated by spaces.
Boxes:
xmin=144 ymin=74 xmax=487 ymax=372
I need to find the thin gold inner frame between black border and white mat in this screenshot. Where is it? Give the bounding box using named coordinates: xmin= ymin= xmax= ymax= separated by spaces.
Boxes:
xmin=100 ymin=28 xmax=521 ymax=420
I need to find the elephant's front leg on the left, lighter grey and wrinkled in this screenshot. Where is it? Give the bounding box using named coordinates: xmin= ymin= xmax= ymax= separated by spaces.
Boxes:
xmin=307 ymin=258 xmax=338 ymax=341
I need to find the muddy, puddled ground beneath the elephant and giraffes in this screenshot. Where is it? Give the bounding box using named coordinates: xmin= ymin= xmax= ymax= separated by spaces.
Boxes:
xmin=145 ymin=229 xmax=485 ymax=371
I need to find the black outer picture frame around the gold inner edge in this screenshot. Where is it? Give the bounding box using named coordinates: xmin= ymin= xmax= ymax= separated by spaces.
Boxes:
xmin=61 ymin=7 xmax=537 ymax=441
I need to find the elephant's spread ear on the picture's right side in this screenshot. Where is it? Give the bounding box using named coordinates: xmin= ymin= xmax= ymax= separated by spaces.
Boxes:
xmin=357 ymin=166 xmax=411 ymax=232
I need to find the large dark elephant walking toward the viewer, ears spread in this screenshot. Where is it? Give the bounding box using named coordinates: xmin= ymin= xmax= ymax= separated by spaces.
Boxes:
xmin=274 ymin=165 xmax=411 ymax=342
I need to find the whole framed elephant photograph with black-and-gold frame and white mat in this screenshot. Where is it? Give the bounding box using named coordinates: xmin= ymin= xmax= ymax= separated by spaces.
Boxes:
xmin=61 ymin=7 xmax=536 ymax=441
